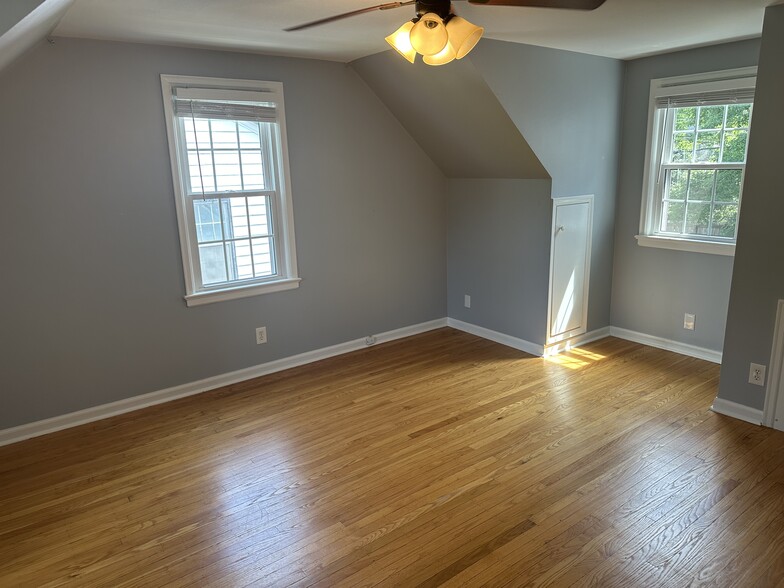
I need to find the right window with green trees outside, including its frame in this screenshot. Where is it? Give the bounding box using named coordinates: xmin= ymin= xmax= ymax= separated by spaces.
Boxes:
xmin=637 ymin=68 xmax=756 ymax=255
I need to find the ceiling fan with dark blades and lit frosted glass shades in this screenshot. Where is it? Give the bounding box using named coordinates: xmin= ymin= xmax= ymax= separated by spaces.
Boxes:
xmin=285 ymin=0 xmax=605 ymax=65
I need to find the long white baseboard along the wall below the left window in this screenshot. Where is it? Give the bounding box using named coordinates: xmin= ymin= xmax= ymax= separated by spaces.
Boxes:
xmin=0 ymin=318 xmax=447 ymax=446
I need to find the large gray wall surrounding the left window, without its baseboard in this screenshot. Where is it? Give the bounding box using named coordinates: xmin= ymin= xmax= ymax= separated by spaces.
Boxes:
xmin=0 ymin=39 xmax=446 ymax=429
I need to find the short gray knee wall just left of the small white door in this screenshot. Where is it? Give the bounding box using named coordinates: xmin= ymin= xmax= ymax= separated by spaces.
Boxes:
xmin=448 ymin=180 xmax=552 ymax=345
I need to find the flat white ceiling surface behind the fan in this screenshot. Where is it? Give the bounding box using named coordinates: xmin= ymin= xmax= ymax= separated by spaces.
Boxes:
xmin=54 ymin=0 xmax=781 ymax=62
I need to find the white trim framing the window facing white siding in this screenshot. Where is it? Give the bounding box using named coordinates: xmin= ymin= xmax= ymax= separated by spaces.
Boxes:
xmin=161 ymin=74 xmax=301 ymax=306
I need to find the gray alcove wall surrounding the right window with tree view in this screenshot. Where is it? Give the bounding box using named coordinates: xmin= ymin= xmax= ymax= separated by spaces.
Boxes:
xmin=611 ymin=40 xmax=759 ymax=350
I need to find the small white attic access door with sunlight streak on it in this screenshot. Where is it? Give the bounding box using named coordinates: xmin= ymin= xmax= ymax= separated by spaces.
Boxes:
xmin=547 ymin=196 xmax=593 ymax=345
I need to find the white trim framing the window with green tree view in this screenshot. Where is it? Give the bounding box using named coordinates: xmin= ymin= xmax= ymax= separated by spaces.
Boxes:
xmin=635 ymin=67 xmax=757 ymax=256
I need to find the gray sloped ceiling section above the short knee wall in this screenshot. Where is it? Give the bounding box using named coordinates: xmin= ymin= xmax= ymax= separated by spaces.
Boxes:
xmin=351 ymin=51 xmax=550 ymax=179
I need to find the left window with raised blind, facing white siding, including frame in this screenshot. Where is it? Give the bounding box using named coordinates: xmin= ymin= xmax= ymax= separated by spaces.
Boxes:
xmin=161 ymin=76 xmax=299 ymax=306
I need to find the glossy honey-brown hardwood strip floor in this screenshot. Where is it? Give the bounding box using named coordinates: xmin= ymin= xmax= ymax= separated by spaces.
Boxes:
xmin=0 ymin=329 xmax=784 ymax=588
